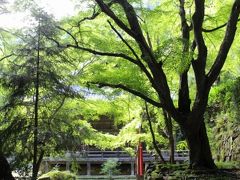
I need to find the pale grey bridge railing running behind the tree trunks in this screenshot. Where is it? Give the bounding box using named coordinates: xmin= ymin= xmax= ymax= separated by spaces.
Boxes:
xmin=42 ymin=150 xmax=189 ymax=175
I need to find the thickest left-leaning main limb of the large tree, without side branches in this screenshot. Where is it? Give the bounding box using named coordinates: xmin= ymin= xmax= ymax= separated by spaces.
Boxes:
xmin=105 ymin=0 xmax=177 ymax=117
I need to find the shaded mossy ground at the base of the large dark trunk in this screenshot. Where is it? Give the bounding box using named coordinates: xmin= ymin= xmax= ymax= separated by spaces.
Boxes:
xmin=145 ymin=165 xmax=240 ymax=180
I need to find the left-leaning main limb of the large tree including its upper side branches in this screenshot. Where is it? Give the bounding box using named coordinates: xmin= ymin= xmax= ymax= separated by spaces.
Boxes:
xmin=53 ymin=0 xmax=178 ymax=121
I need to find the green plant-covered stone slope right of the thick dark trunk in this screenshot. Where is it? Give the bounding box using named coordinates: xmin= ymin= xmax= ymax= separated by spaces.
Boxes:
xmin=207 ymin=78 xmax=240 ymax=161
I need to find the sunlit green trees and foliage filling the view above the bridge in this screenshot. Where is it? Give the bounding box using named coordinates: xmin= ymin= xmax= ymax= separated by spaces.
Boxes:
xmin=0 ymin=0 xmax=240 ymax=179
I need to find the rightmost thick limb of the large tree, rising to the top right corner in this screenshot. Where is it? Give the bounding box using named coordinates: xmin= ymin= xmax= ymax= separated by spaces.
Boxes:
xmin=207 ymin=0 xmax=240 ymax=87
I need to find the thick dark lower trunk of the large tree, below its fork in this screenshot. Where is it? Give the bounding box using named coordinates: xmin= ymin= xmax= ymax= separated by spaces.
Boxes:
xmin=182 ymin=117 xmax=216 ymax=169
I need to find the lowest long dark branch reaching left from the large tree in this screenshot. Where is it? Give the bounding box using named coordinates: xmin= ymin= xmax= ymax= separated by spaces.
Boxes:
xmin=91 ymin=82 xmax=162 ymax=107
